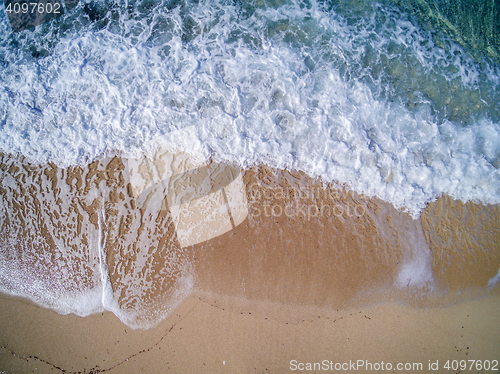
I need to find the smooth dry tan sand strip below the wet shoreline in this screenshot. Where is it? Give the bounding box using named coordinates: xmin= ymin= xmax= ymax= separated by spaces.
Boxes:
xmin=0 ymin=294 xmax=500 ymax=373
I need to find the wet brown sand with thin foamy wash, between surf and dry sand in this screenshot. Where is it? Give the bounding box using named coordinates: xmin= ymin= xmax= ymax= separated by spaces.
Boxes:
xmin=0 ymin=152 xmax=500 ymax=328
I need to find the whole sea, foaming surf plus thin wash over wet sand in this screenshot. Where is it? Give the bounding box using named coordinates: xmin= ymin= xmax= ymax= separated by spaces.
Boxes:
xmin=0 ymin=0 xmax=500 ymax=327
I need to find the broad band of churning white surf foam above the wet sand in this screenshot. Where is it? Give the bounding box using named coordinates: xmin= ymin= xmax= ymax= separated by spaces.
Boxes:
xmin=0 ymin=2 xmax=500 ymax=216
